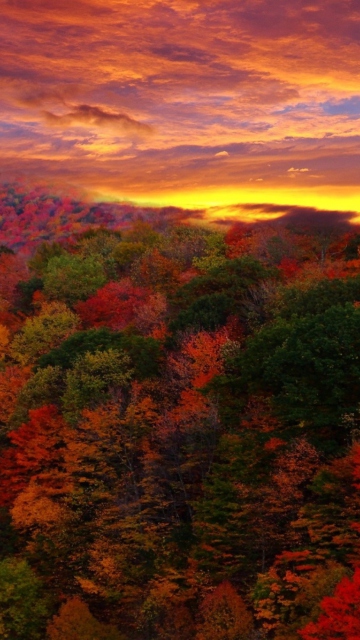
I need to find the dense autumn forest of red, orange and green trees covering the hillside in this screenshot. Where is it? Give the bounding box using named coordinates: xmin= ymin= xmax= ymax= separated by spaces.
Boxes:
xmin=0 ymin=185 xmax=360 ymax=640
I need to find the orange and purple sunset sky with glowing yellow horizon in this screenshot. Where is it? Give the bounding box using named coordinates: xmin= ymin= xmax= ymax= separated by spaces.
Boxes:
xmin=0 ymin=0 xmax=360 ymax=221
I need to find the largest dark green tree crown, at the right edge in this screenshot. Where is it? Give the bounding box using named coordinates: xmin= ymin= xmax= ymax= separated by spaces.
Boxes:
xmin=228 ymin=305 xmax=360 ymax=443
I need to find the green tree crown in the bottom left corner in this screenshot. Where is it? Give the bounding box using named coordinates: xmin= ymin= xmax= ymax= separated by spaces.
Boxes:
xmin=0 ymin=558 xmax=48 ymax=640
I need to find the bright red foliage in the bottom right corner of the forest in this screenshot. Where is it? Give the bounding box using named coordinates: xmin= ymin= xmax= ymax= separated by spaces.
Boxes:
xmin=298 ymin=568 xmax=360 ymax=640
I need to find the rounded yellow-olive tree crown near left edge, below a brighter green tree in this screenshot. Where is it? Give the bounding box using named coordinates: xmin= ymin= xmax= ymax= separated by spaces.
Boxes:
xmin=11 ymin=302 xmax=79 ymax=365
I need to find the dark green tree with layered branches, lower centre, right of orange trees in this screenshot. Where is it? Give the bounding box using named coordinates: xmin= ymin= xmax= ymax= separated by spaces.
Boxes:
xmin=194 ymin=432 xmax=270 ymax=580
